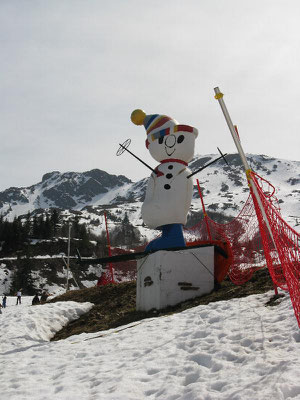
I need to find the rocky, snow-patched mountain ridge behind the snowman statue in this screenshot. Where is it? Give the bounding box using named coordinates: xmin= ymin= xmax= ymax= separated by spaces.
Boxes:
xmin=0 ymin=153 xmax=300 ymax=234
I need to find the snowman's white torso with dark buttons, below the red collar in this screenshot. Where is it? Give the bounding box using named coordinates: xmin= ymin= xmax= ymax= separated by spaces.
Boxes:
xmin=142 ymin=161 xmax=193 ymax=229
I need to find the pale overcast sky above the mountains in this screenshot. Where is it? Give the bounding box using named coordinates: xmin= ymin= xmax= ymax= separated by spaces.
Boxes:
xmin=0 ymin=0 xmax=300 ymax=190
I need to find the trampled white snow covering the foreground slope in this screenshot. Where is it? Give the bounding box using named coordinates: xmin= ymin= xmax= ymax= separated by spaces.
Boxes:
xmin=0 ymin=292 xmax=300 ymax=400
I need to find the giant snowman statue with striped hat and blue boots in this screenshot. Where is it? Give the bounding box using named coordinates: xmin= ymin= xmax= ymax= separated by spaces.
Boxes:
xmin=131 ymin=110 xmax=198 ymax=251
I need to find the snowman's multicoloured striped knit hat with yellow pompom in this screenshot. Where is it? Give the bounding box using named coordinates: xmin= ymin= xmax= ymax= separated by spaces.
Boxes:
xmin=131 ymin=110 xmax=198 ymax=148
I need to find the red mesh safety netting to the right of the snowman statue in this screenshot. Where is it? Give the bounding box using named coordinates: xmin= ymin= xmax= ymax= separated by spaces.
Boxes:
xmin=184 ymin=175 xmax=300 ymax=326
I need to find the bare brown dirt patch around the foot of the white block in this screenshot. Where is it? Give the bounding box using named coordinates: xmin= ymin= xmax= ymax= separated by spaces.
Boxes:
xmin=50 ymin=269 xmax=273 ymax=340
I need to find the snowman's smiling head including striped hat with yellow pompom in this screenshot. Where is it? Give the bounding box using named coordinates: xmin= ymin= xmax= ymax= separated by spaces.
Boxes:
xmin=131 ymin=110 xmax=198 ymax=162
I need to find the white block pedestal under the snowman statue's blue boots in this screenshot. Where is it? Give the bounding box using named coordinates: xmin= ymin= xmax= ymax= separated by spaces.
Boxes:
xmin=136 ymin=246 xmax=214 ymax=311
